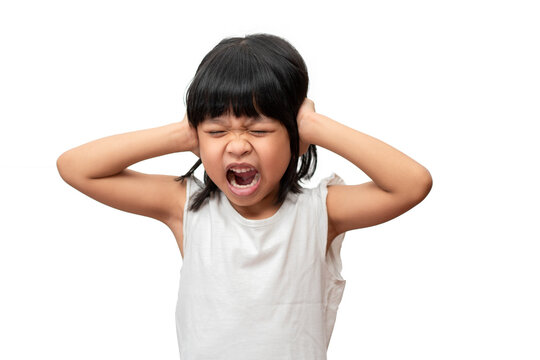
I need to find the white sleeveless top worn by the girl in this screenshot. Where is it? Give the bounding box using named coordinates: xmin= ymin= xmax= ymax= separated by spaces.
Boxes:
xmin=176 ymin=174 xmax=346 ymax=360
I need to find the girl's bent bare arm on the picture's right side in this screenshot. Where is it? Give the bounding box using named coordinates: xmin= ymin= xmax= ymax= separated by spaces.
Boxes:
xmin=298 ymin=98 xmax=432 ymax=240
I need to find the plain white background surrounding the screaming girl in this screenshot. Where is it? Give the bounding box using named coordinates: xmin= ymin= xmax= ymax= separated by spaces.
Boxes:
xmin=0 ymin=0 xmax=540 ymax=360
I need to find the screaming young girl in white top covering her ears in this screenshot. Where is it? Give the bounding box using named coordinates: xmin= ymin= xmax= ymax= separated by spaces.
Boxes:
xmin=57 ymin=34 xmax=432 ymax=360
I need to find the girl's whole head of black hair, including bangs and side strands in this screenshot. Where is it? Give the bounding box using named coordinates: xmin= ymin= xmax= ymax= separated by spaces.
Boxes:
xmin=175 ymin=34 xmax=317 ymax=210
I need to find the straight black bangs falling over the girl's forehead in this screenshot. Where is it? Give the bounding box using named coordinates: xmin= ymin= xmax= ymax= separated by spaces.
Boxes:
xmin=187 ymin=46 xmax=290 ymax=127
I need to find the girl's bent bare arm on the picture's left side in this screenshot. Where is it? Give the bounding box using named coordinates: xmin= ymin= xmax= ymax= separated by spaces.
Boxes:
xmin=56 ymin=116 xmax=198 ymax=227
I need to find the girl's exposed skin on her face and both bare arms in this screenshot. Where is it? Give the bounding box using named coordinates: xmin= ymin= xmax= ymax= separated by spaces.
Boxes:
xmin=56 ymin=98 xmax=432 ymax=256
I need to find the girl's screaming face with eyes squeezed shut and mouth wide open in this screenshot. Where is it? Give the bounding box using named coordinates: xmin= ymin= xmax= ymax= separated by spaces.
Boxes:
xmin=197 ymin=114 xmax=291 ymax=219
